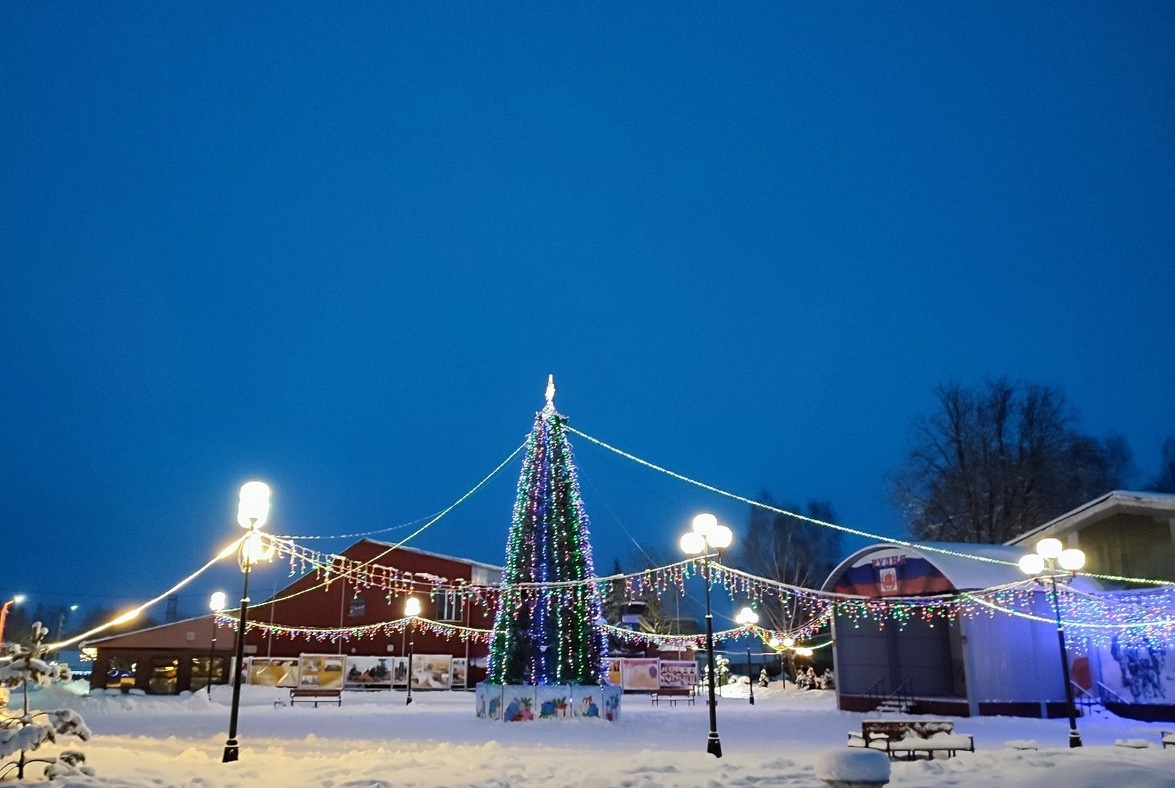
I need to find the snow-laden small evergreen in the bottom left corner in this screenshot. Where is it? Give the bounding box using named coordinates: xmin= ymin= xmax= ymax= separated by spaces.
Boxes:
xmin=0 ymin=621 xmax=94 ymax=780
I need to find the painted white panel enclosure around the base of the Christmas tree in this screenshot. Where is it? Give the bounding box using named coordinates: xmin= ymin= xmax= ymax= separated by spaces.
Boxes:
xmin=477 ymin=681 xmax=622 ymax=722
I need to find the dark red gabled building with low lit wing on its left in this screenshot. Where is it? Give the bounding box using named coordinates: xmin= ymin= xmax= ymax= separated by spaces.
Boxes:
xmin=86 ymin=539 xmax=502 ymax=694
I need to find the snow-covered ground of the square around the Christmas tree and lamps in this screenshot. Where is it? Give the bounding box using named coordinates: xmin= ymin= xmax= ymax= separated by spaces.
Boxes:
xmin=14 ymin=687 xmax=1175 ymax=788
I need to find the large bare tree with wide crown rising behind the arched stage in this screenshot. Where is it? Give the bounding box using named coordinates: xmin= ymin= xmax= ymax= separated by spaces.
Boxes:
xmin=893 ymin=379 xmax=1132 ymax=543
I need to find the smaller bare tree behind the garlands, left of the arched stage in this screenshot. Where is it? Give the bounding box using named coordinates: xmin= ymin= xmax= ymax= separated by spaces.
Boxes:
xmin=739 ymin=500 xmax=840 ymax=632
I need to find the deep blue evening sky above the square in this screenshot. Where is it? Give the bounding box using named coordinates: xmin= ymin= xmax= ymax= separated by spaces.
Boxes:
xmin=0 ymin=2 xmax=1175 ymax=624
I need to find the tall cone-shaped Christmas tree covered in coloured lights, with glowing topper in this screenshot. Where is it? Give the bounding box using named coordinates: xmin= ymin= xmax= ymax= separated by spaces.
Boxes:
xmin=488 ymin=376 xmax=606 ymax=685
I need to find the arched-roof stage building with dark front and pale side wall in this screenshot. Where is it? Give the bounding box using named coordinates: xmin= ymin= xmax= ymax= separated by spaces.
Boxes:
xmin=824 ymin=543 xmax=1097 ymax=718
